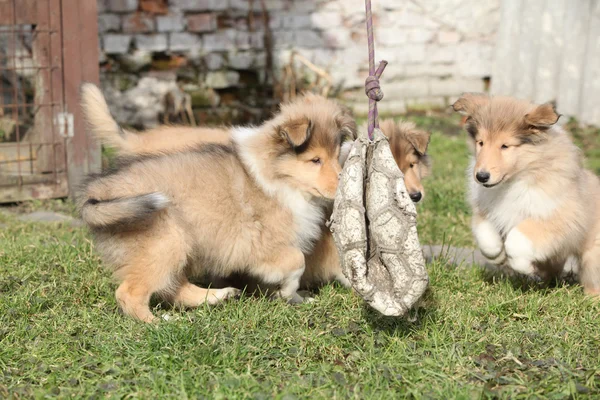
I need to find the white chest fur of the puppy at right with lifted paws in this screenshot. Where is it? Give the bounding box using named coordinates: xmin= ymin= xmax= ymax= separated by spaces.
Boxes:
xmin=470 ymin=161 xmax=561 ymax=234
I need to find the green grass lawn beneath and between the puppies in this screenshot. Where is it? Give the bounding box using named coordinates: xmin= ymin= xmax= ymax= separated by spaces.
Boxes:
xmin=0 ymin=116 xmax=600 ymax=399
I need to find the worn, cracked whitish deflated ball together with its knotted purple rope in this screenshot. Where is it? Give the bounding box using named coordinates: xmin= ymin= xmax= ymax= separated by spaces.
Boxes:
xmin=330 ymin=0 xmax=429 ymax=316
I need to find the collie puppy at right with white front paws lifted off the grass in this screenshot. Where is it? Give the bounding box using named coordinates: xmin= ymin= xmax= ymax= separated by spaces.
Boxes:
xmin=453 ymin=94 xmax=600 ymax=295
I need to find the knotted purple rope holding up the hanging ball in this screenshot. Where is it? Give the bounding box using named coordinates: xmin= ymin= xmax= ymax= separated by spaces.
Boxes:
xmin=365 ymin=0 xmax=387 ymax=140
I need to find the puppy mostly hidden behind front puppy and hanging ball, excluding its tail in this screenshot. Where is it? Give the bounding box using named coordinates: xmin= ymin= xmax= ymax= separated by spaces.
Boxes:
xmin=89 ymin=111 xmax=430 ymax=289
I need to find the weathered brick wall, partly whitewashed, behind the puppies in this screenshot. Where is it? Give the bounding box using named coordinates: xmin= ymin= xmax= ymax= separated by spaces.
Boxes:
xmin=98 ymin=0 xmax=499 ymax=126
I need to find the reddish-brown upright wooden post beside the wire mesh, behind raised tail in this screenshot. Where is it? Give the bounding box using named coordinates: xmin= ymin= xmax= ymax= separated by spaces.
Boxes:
xmin=62 ymin=0 xmax=101 ymax=197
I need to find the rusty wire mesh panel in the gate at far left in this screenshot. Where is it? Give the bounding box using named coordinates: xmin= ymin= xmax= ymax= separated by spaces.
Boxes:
xmin=0 ymin=0 xmax=66 ymax=201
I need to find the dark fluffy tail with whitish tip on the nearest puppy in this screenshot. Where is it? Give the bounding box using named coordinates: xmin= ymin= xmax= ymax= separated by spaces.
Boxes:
xmin=81 ymin=192 xmax=169 ymax=229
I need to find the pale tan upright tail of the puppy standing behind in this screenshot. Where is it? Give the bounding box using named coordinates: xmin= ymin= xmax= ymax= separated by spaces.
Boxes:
xmin=81 ymin=83 xmax=136 ymax=154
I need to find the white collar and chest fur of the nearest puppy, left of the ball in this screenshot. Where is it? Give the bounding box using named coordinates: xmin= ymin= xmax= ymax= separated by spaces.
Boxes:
xmin=232 ymin=127 xmax=324 ymax=253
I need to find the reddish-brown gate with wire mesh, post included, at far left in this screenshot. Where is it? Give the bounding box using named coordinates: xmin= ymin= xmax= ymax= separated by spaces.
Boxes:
xmin=0 ymin=0 xmax=100 ymax=202
